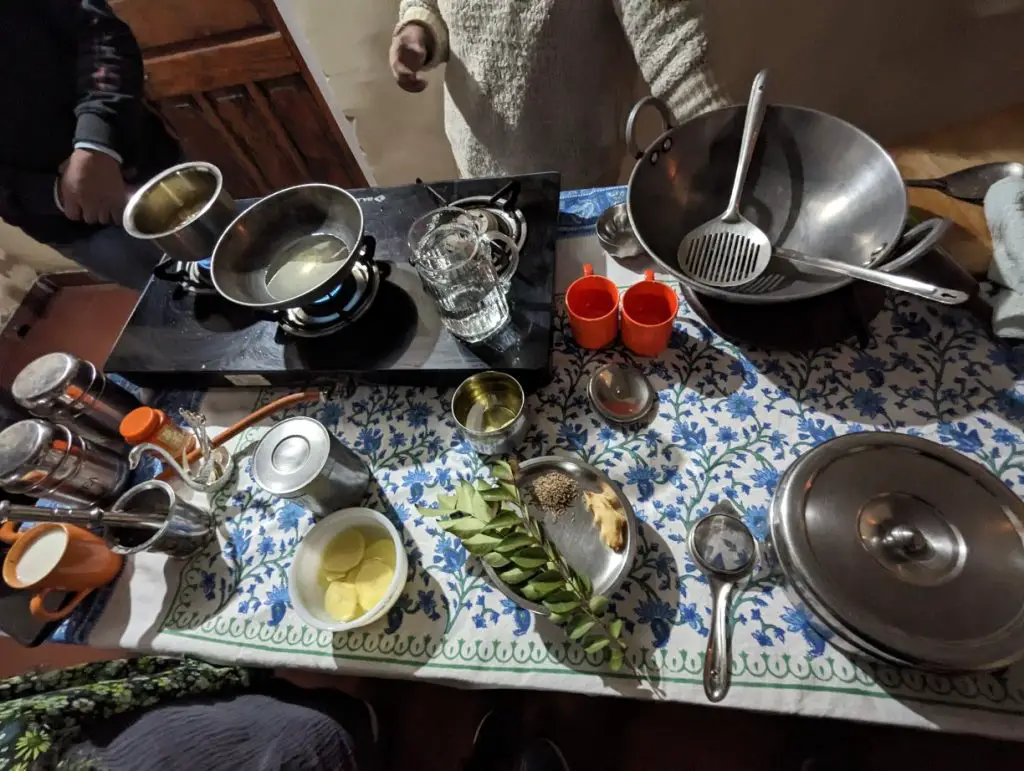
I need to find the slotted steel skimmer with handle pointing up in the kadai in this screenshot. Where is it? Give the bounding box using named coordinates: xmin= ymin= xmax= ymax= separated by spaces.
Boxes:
xmin=677 ymin=70 xmax=771 ymax=289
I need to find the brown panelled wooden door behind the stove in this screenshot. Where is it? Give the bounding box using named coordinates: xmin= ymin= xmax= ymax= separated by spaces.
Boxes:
xmin=111 ymin=0 xmax=366 ymax=198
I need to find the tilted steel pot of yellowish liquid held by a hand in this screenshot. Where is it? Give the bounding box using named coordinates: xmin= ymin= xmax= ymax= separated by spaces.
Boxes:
xmin=124 ymin=161 xmax=237 ymax=262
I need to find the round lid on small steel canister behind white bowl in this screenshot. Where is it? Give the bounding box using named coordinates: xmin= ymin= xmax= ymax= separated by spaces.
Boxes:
xmin=253 ymin=416 xmax=331 ymax=496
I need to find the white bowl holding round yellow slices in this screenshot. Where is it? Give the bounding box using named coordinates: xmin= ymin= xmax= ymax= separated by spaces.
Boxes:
xmin=288 ymin=508 xmax=409 ymax=632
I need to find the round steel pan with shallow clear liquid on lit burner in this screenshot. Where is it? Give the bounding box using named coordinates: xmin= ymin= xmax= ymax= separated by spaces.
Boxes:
xmin=210 ymin=183 xmax=373 ymax=310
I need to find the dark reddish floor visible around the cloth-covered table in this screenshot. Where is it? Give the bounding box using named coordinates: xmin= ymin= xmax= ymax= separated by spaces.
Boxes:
xmin=0 ymin=286 xmax=1024 ymax=771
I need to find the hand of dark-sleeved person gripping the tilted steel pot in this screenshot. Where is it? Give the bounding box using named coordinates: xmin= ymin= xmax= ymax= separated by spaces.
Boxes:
xmin=59 ymin=148 xmax=128 ymax=225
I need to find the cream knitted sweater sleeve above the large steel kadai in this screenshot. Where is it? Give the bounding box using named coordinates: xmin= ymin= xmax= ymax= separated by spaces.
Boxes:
xmin=614 ymin=0 xmax=728 ymax=121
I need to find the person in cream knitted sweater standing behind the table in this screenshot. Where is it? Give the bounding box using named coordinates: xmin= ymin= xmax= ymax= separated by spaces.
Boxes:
xmin=390 ymin=0 xmax=725 ymax=188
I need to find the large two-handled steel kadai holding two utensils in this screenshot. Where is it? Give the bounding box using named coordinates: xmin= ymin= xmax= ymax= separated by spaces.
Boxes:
xmin=626 ymin=96 xmax=946 ymax=303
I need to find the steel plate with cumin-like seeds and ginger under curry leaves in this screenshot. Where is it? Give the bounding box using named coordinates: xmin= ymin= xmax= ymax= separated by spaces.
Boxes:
xmin=483 ymin=456 xmax=637 ymax=615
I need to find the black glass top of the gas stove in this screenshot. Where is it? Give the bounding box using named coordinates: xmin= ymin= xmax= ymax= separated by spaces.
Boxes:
xmin=105 ymin=173 xmax=560 ymax=389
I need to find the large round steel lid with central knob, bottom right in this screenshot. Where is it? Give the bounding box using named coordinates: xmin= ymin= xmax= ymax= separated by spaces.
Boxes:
xmin=771 ymin=432 xmax=1024 ymax=670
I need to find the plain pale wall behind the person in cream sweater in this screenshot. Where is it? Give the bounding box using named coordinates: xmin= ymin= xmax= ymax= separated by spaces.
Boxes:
xmin=275 ymin=0 xmax=1024 ymax=184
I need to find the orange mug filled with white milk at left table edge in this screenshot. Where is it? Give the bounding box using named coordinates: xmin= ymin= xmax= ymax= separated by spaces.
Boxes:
xmin=3 ymin=522 xmax=124 ymax=622
